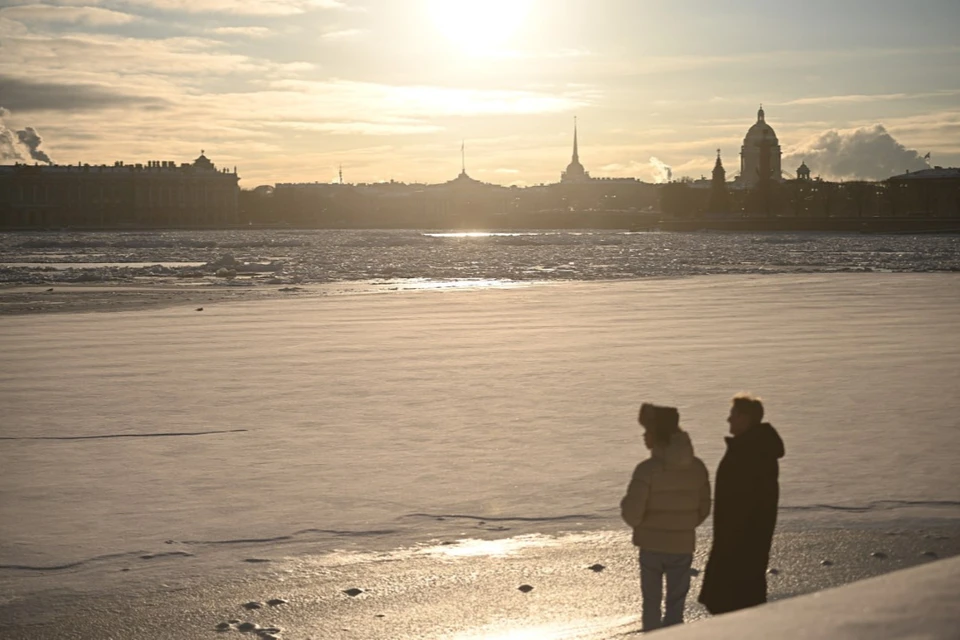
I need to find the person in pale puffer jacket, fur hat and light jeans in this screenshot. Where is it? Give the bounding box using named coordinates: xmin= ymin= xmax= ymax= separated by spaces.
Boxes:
xmin=620 ymin=403 xmax=710 ymax=631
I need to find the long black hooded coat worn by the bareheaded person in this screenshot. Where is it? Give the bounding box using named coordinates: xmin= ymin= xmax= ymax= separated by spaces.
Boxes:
xmin=699 ymin=423 xmax=784 ymax=614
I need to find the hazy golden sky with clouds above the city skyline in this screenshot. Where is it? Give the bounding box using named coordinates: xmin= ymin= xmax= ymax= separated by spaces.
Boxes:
xmin=0 ymin=0 xmax=960 ymax=188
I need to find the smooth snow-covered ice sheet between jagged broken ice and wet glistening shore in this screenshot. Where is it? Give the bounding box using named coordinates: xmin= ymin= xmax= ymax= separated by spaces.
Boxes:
xmin=0 ymin=274 xmax=960 ymax=596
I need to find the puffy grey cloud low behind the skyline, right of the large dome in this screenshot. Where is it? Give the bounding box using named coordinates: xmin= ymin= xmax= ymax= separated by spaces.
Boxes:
xmin=783 ymin=124 xmax=928 ymax=180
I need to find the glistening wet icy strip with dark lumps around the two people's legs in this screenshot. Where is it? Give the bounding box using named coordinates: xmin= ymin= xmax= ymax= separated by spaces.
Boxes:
xmin=0 ymin=524 xmax=960 ymax=640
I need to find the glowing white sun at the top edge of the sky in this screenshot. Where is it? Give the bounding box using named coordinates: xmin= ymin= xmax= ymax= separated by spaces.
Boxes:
xmin=429 ymin=0 xmax=530 ymax=54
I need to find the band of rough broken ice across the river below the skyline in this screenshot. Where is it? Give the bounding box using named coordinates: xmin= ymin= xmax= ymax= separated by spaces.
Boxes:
xmin=0 ymin=230 xmax=960 ymax=286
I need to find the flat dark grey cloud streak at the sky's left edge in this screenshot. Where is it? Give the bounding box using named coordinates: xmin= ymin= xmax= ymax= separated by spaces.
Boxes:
xmin=0 ymin=76 xmax=164 ymax=113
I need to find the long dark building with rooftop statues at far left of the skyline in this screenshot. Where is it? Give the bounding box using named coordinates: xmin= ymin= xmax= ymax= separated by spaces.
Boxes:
xmin=0 ymin=152 xmax=239 ymax=228
